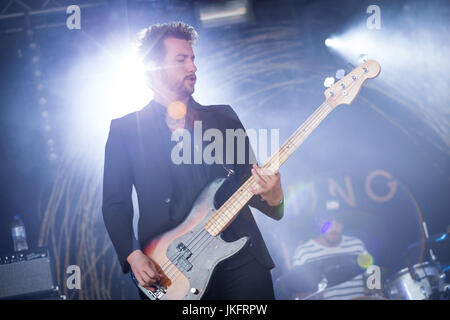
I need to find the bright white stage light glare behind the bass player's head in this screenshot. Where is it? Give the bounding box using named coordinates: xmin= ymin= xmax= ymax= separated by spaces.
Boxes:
xmin=60 ymin=43 xmax=153 ymax=152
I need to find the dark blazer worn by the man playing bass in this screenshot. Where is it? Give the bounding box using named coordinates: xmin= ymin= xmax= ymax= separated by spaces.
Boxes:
xmin=102 ymin=98 xmax=283 ymax=273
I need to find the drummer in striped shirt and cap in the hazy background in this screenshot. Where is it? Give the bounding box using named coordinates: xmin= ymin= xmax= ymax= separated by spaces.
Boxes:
xmin=292 ymin=201 xmax=369 ymax=300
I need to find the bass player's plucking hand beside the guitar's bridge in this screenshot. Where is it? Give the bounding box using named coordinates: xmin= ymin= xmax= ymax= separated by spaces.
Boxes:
xmin=127 ymin=250 xmax=162 ymax=291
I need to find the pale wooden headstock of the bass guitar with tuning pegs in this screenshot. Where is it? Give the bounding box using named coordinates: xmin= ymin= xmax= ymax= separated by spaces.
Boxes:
xmin=324 ymin=60 xmax=381 ymax=108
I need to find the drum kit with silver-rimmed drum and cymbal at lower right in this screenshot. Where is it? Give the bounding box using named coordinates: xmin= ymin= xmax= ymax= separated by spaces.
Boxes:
xmin=275 ymin=233 xmax=450 ymax=300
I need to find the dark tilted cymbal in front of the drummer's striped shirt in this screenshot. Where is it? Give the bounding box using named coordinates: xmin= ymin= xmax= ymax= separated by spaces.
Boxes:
xmin=276 ymin=254 xmax=364 ymax=294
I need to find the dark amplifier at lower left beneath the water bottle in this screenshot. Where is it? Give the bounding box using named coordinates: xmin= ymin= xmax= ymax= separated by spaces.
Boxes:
xmin=0 ymin=248 xmax=58 ymax=299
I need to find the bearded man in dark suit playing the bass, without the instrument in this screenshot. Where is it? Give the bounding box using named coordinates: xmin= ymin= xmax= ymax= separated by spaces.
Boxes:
xmin=102 ymin=22 xmax=283 ymax=299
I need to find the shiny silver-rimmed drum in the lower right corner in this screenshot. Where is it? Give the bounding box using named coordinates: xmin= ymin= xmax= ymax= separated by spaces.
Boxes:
xmin=384 ymin=262 xmax=445 ymax=300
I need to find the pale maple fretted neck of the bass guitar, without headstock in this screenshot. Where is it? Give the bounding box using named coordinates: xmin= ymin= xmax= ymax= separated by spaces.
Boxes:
xmin=205 ymin=101 xmax=333 ymax=236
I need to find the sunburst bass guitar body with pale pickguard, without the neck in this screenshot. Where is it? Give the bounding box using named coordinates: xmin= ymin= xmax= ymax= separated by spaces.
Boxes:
xmin=139 ymin=178 xmax=248 ymax=300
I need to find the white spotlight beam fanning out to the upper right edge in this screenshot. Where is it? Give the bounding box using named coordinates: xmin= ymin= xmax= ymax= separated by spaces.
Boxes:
xmin=326 ymin=6 xmax=450 ymax=154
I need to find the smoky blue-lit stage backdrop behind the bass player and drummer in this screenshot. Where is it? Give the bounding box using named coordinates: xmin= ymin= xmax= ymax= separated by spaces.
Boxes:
xmin=0 ymin=0 xmax=450 ymax=299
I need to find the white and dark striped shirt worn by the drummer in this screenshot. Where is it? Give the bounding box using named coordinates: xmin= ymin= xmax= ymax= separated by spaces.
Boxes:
xmin=293 ymin=235 xmax=367 ymax=300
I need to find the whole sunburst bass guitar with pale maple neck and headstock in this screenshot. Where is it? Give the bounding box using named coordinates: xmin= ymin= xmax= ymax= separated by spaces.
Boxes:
xmin=131 ymin=60 xmax=380 ymax=300
